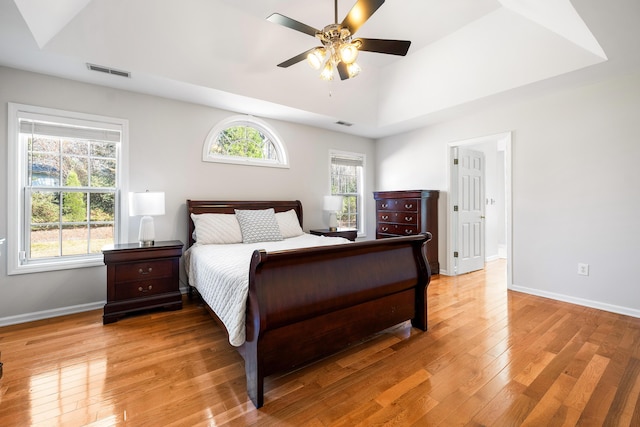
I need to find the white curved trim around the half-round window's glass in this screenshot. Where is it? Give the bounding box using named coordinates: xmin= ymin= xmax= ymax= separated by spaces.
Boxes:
xmin=202 ymin=115 xmax=289 ymax=168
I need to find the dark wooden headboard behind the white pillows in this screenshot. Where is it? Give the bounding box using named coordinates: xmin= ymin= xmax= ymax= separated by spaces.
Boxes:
xmin=187 ymin=200 xmax=302 ymax=247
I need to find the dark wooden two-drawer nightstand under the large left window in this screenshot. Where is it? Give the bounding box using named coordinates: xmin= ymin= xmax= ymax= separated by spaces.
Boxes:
xmin=102 ymin=240 xmax=183 ymax=324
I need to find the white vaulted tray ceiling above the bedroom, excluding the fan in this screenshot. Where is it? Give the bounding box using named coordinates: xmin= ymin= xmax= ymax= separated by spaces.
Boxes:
xmin=0 ymin=0 xmax=640 ymax=138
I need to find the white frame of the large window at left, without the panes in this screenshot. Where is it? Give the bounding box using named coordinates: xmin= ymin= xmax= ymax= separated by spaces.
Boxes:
xmin=7 ymin=102 xmax=129 ymax=275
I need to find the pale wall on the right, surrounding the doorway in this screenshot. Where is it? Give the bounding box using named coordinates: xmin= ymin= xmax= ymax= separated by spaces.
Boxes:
xmin=376 ymin=74 xmax=640 ymax=317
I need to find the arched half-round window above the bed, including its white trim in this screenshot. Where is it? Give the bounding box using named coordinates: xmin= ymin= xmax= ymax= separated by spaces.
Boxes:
xmin=202 ymin=116 xmax=289 ymax=168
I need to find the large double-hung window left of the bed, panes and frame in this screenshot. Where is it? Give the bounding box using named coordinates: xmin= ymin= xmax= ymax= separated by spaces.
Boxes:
xmin=7 ymin=103 xmax=128 ymax=274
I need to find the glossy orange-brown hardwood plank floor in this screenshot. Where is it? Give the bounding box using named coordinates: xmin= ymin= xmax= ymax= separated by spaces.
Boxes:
xmin=0 ymin=261 xmax=640 ymax=426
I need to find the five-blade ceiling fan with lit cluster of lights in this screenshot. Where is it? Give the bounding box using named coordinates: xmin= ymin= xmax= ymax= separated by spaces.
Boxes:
xmin=267 ymin=0 xmax=411 ymax=80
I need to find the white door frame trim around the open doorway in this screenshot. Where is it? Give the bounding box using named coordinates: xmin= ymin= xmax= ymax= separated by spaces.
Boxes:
xmin=447 ymin=131 xmax=513 ymax=289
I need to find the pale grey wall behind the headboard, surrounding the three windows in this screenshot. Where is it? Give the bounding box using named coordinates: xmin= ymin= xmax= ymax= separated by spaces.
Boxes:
xmin=0 ymin=67 xmax=376 ymax=324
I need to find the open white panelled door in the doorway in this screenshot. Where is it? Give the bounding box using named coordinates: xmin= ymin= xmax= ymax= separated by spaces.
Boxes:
xmin=457 ymin=147 xmax=485 ymax=274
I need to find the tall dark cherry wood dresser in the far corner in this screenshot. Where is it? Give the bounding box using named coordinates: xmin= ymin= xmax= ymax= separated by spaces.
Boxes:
xmin=373 ymin=190 xmax=440 ymax=274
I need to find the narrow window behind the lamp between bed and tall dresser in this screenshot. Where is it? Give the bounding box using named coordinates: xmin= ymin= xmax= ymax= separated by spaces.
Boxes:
xmin=329 ymin=151 xmax=365 ymax=235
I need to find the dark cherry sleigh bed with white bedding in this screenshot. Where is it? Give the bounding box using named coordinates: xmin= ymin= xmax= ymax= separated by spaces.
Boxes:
xmin=185 ymin=200 xmax=430 ymax=408
